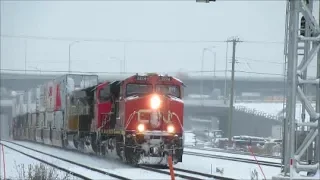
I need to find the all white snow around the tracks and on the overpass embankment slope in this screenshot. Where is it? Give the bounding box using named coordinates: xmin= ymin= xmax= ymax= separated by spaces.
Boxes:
xmin=0 ymin=103 xmax=320 ymax=179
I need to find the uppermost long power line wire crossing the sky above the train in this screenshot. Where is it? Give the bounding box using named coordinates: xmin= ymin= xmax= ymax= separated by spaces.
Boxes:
xmin=1 ymin=34 xmax=283 ymax=44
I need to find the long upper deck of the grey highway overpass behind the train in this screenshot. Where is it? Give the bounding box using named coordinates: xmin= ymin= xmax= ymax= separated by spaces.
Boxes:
xmin=1 ymin=73 xmax=292 ymax=96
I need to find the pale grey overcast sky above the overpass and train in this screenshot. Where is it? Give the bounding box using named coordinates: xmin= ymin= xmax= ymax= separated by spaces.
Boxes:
xmin=1 ymin=0 xmax=316 ymax=76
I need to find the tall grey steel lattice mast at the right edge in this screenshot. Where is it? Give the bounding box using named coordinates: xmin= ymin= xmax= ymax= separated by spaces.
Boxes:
xmin=196 ymin=0 xmax=320 ymax=179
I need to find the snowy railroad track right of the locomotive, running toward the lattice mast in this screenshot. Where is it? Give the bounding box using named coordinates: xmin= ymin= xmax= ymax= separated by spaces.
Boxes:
xmin=183 ymin=151 xmax=281 ymax=167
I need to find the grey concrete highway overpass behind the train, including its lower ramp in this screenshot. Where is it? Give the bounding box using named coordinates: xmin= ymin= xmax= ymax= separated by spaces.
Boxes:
xmin=1 ymin=73 xmax=283 ymax=136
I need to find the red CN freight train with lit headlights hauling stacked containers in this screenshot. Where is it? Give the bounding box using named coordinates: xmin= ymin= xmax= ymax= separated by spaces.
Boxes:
xmin=12 ymin=73 xmax=184 ymax=165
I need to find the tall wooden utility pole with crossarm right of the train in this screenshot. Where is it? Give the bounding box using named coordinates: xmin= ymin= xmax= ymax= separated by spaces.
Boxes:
xmin=227 ymin=38 xmax=240 ymax=145
